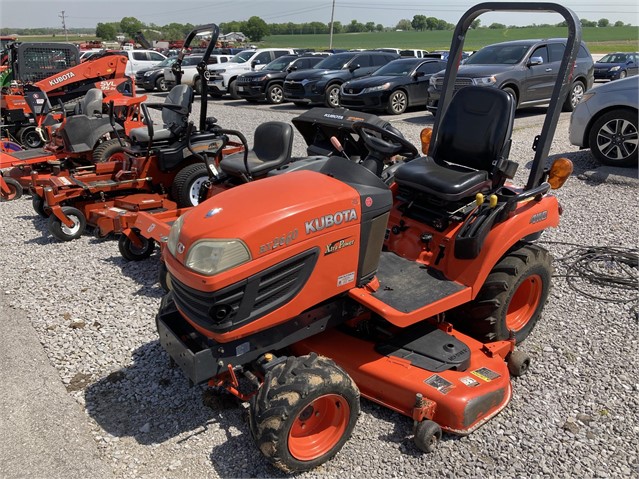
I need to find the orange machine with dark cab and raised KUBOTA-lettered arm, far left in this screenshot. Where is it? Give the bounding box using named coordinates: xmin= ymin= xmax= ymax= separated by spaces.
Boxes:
xmin=0 ymin=43 xmax=135 ymax=148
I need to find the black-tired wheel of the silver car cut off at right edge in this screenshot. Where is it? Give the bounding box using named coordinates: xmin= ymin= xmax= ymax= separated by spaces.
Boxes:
xmin=588 ymin=109 xmax=638 ymax=166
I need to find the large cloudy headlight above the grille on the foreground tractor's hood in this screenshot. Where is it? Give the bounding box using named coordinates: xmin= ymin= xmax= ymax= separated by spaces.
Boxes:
xmin=184 ymin=239 xmax=251 ymax=276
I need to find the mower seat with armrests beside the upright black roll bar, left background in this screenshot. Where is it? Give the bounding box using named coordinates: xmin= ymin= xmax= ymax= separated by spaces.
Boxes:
xmin=129 ymin=85 xmax=193 ymax=143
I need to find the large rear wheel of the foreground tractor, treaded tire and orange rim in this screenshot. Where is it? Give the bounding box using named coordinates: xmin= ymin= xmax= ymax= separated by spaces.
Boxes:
xmin=451 ymin=244 xmax=553 ymax=344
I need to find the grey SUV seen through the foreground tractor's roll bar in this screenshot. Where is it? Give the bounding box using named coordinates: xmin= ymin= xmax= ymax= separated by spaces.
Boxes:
xmin=426 ymin=38 xmax=594 ymax=114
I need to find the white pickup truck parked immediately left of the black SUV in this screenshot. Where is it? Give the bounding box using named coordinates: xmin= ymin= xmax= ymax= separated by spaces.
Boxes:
xmin=207 ymin=48 xmax=295 ymax=100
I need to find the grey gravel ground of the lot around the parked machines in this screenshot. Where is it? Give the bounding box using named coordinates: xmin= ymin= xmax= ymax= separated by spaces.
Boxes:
xmin=0 ymin=95 xmax=639 ymax=478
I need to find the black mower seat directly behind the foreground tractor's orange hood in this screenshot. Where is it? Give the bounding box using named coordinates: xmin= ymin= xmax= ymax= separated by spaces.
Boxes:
xmin=220 ymin=121 xmax=293 ymax=178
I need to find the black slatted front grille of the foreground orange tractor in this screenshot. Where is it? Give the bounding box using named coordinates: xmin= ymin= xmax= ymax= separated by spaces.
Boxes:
xmin=171 ymin=248 xmax=319 ymax=333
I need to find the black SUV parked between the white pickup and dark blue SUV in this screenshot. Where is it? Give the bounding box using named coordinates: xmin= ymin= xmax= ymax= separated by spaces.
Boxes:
xmin=236 ymin=55 xmax=324 ymax=104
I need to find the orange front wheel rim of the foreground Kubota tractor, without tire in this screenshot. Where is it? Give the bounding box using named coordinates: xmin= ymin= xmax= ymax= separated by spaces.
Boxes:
xmin=288 ymin=394 xmax=351 ymax=461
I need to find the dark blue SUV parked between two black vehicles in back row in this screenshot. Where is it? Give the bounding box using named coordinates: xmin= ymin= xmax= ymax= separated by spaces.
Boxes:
xmin=284 ymin=51 xmax=400 ymax=108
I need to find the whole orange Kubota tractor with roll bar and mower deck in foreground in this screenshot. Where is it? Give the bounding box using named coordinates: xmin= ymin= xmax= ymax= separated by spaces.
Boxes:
xmin=156 ymin=2 xmax=581 ymax=472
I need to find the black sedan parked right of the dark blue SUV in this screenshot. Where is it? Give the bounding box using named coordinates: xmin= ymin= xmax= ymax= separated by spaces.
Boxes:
xmin=339 ymin=58 xmax=446 ymax=115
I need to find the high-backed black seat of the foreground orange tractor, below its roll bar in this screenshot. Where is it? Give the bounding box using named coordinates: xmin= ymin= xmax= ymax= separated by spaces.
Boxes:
xmin=395 ymin=86 xmax=517 ymax=201
